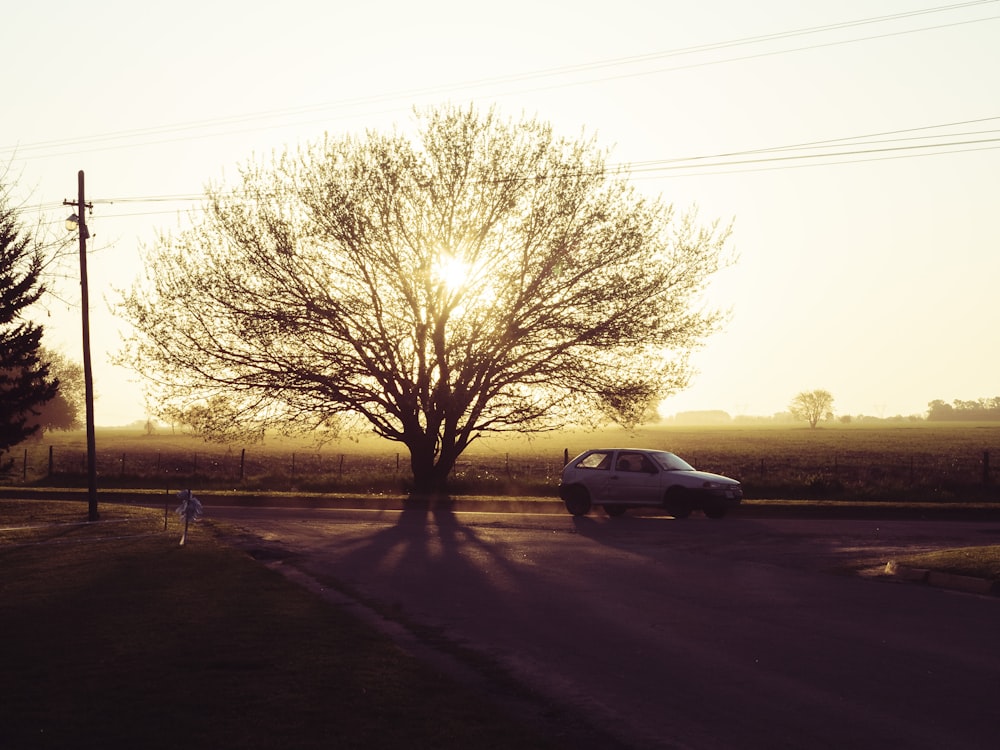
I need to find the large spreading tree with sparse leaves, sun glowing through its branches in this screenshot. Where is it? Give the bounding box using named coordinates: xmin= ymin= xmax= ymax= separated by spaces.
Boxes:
xmin=120 ymin=107 xmax=730 ymax=494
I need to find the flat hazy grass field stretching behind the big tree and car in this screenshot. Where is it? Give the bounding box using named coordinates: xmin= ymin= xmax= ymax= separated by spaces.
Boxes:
xmin=10 ymin=422 xmax=1000 ymax=501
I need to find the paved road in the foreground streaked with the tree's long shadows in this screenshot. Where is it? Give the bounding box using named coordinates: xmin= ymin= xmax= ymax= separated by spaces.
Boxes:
xmin=211 ymin=508 xmax=1000 ymax=750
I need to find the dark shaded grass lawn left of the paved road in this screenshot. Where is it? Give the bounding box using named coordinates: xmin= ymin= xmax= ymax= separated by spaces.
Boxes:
xmin=0 ymin=501 xmax=576 ymax=750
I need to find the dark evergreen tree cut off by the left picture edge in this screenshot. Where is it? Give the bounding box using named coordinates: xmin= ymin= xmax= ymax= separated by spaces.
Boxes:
xmin=0 ymin=191 xmax=58 ymax=471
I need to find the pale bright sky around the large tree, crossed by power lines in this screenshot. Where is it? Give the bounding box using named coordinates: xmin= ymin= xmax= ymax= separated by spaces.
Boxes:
xmin=0 ymin=0 xmax=1000 ymax=425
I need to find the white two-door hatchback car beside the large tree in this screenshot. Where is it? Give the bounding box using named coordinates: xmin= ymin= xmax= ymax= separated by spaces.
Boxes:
xmin=559 ymin=448 xmax=743 ymax=518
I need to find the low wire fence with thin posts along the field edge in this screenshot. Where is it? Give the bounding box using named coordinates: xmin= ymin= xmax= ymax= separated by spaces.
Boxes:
xmin=5 ymin=445 xmax=998 ymax=496
